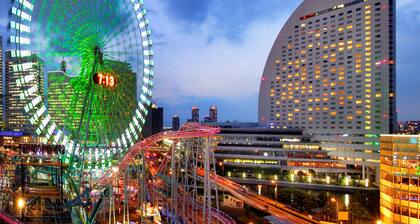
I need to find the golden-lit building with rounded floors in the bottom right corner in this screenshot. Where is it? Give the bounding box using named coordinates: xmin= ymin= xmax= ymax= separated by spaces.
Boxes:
xmin=380 ymin=135 xmax=420 ymax=224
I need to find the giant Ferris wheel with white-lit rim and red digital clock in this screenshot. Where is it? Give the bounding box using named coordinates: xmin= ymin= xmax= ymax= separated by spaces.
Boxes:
xmin=9 ymin=0 xmax=154 ymax=170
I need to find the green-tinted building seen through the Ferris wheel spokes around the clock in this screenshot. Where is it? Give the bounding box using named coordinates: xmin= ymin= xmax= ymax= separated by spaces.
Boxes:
xmin=47 ymin=60 xmax=137 ymax=135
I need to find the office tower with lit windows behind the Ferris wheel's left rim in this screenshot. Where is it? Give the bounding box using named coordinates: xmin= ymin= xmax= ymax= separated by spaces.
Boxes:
xmin=5 ymin=51 xmax=44 ymax=133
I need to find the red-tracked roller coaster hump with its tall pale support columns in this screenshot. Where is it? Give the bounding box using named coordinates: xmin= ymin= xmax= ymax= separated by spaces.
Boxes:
xmin=97 ymin=123 xmax=235 ymax=223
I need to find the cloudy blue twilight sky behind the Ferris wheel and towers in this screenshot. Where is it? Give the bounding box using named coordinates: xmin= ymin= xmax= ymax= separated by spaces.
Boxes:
xmin=0 ymin=0 xmax=420 ymax=125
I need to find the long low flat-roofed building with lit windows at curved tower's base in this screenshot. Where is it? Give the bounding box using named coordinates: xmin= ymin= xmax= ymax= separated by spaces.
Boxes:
xmin=214 ymin=127 xmax=373 ymax=187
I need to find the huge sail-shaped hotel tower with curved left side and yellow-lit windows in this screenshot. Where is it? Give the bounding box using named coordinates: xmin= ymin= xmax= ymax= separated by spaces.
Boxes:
xmin=259 ymin=0 xmax=397 ymax=181
